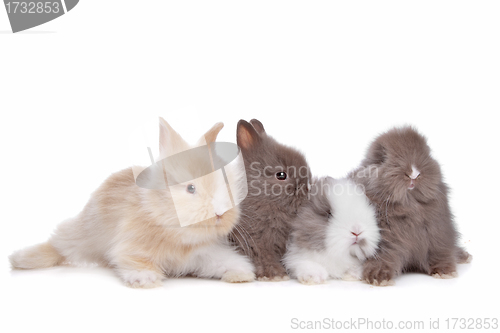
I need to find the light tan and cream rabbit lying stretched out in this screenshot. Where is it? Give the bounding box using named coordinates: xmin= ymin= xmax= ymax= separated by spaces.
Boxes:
xmin=9 ymin=118 xmax=255 ymax=288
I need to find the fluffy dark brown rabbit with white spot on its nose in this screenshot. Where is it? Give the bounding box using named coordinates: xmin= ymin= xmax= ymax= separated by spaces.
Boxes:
xmin=350 ymin=127 xmax=472 ymax=285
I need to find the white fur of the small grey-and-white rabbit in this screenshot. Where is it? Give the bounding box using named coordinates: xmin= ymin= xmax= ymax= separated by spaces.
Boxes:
xmin=284 ymin=179 xmax=380 ymax=284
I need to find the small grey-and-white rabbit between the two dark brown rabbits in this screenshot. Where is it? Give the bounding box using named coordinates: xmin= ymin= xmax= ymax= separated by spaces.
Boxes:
xmin=283 ymin=177 xmax=380 ymax=284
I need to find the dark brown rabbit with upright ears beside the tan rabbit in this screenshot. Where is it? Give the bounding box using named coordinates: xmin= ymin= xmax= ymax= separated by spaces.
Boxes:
xmin=230 ymin=119 xmax=310 ymax=281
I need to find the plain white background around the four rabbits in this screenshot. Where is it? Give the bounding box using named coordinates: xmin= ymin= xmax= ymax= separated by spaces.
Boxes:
xmin=0 ymin=0 xmax=500 ymax=332
